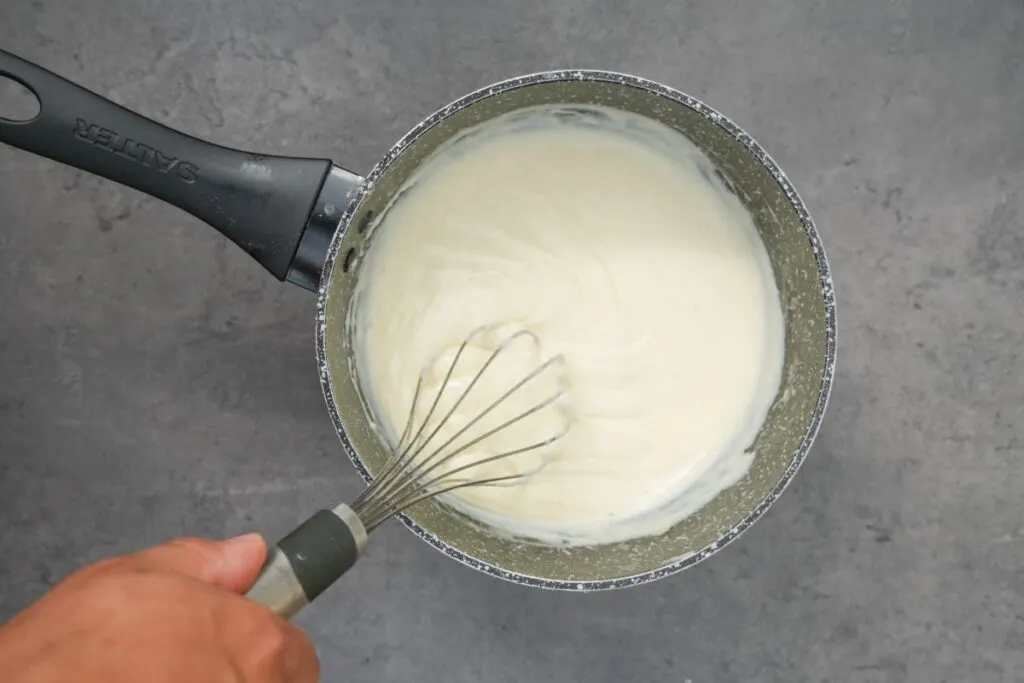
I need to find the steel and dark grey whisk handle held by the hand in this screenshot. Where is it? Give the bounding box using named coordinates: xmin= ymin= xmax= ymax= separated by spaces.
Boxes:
xmin=246 ymin=504 xmax=367 ymax=618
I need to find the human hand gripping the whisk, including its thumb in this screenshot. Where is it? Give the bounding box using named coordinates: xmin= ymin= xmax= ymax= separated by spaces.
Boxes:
xmin=0 ymin=535 xmax=319 ymax=683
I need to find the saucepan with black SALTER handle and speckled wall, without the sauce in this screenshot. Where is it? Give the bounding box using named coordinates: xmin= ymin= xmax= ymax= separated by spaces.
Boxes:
xmin=0 ymin=52 xmax=836 ymax=591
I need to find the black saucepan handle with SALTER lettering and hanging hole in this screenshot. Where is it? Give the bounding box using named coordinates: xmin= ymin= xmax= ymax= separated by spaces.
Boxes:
xmin=0 ymin=50 xmax=344 ymax=289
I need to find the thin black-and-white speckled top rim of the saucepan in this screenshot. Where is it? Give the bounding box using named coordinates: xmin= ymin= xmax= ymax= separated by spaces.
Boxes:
xmin=316 ymin=70 xmax=837 ymax=592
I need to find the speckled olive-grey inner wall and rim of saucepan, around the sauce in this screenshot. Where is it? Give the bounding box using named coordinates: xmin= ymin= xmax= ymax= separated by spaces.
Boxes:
xmin=317 ymin=72 xmax=836 ymax=590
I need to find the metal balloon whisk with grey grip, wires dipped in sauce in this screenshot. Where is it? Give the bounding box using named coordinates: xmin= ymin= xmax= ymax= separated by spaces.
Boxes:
xmin=247 ymin=326 xmax=569 ymax=618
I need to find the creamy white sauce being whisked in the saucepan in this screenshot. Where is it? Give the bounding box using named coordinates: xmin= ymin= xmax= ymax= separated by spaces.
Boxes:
xmin=355 ymin=108 xmax=783 ymax=545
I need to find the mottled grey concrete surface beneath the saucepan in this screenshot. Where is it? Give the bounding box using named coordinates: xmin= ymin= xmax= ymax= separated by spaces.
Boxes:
xmin=0 ymin=0 xmax=1024 ymax=683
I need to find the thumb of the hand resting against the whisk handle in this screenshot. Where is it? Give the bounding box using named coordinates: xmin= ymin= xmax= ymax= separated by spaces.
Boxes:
xmin=126 ymin=533 xmax=266 ymax=593
